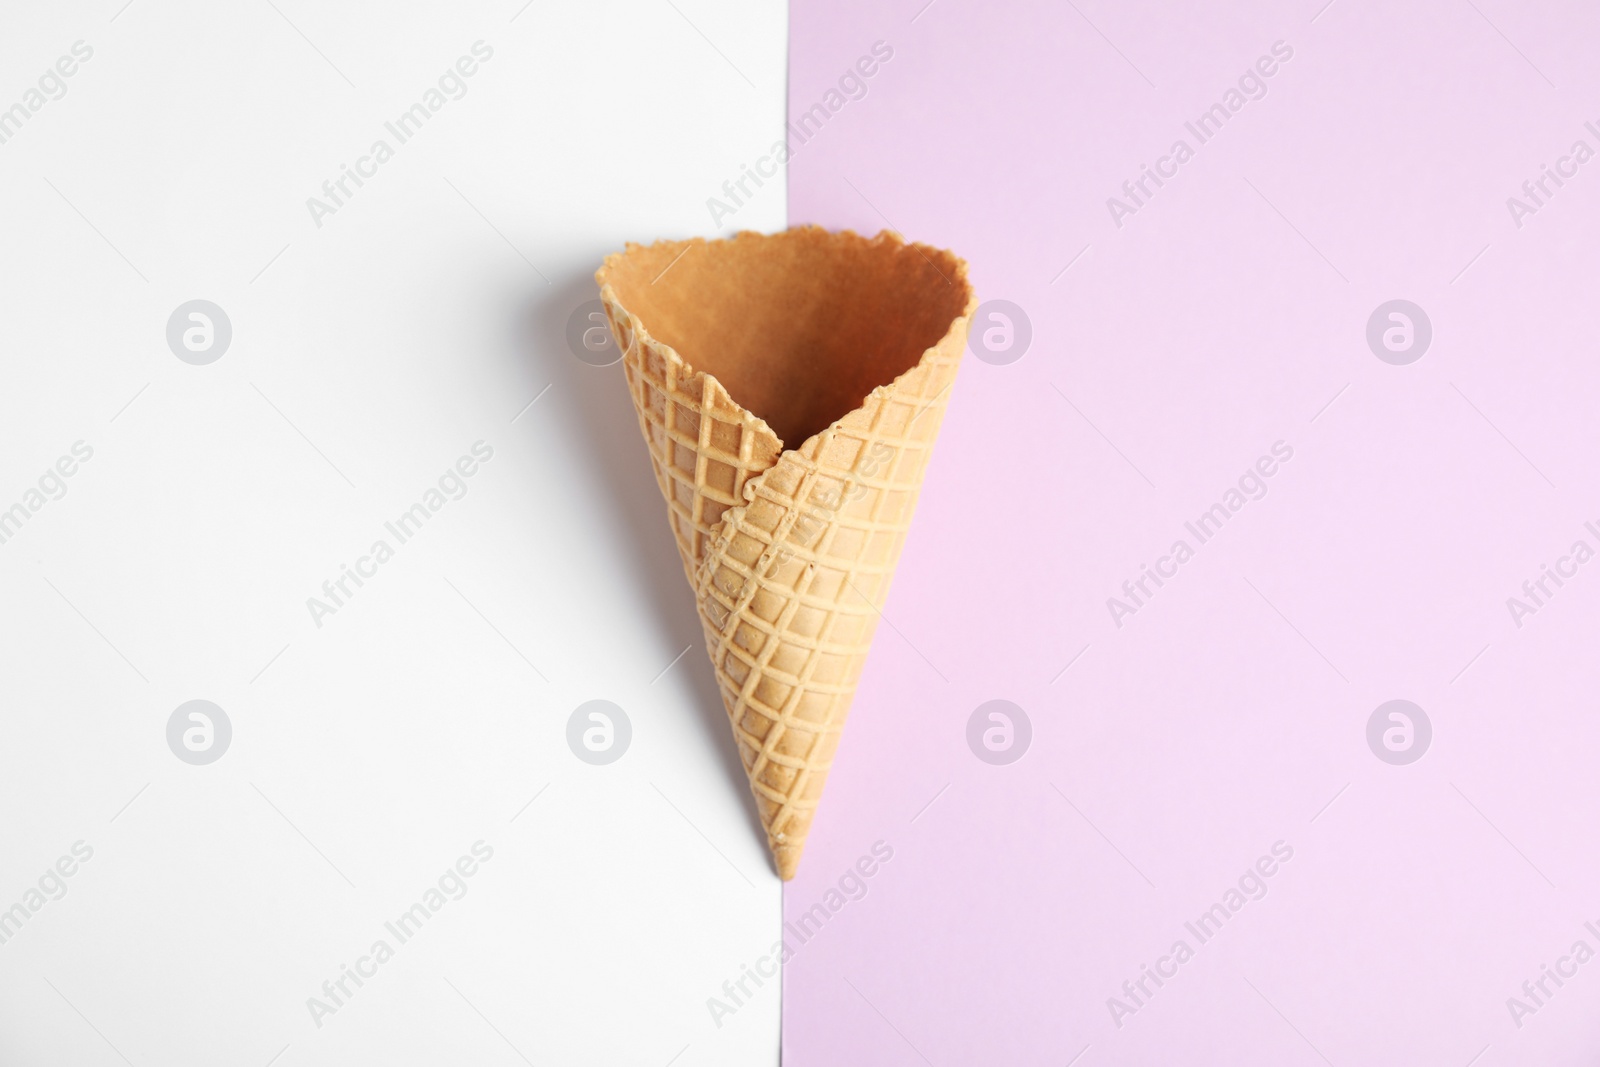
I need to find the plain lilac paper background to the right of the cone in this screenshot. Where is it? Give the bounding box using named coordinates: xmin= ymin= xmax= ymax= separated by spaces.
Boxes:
xmin=784 ymin=0 xmax=1600 ymax=1067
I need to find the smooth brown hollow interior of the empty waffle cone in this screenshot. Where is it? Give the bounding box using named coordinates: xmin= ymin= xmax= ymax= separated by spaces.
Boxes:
xmin=610 ymin=230 xmax=968 ymax=448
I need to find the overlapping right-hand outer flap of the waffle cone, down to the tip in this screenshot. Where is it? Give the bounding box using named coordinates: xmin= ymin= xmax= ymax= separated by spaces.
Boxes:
xmin=696 ymin=348 xmax=957 ymax=867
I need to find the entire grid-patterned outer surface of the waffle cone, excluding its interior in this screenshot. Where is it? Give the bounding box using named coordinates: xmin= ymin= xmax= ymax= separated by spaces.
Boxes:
xmin=602 ymin=238 xmax=978 ymax=878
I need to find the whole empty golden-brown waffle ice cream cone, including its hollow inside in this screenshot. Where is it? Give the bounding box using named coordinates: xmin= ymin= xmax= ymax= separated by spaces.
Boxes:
xmin=595 ymin=226 xmax=978 ymax=880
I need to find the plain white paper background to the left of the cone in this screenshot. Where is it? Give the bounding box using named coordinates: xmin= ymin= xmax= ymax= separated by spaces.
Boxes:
xmin=0 ymin=0 xmax=786 ymax=1067
